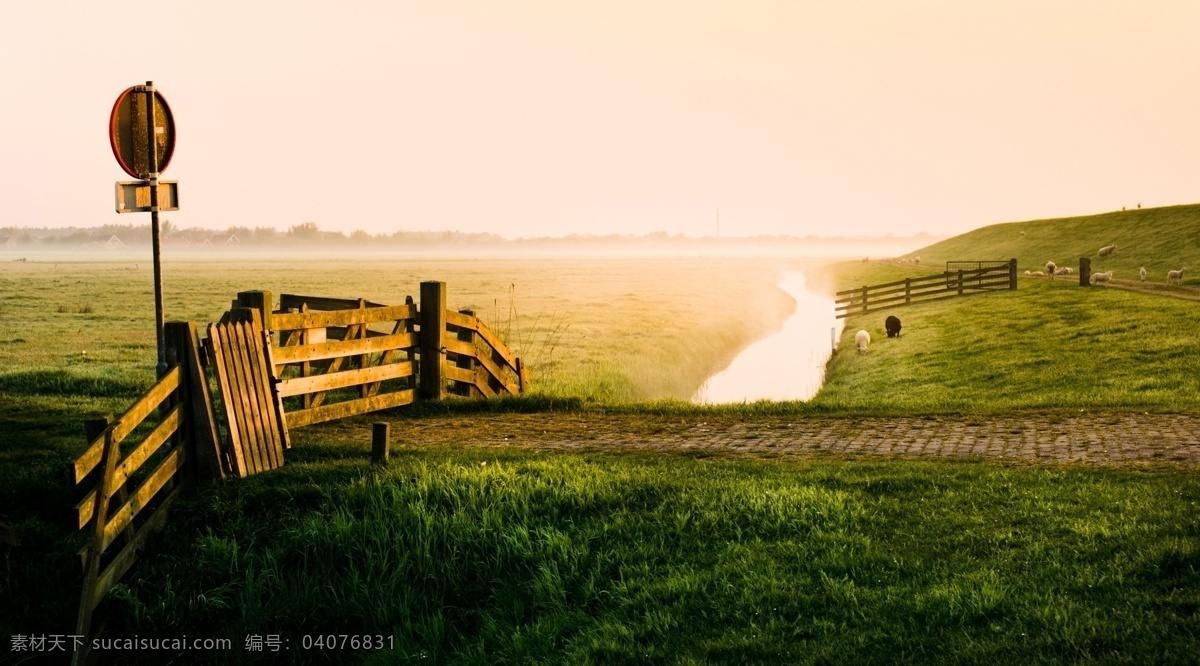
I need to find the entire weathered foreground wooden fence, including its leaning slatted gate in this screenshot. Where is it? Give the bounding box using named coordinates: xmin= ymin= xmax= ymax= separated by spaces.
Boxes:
xmin=71 ymin=282 xmax=529 ymax=662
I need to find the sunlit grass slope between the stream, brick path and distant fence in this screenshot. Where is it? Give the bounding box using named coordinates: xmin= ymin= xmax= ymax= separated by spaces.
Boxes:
xmin=809 ymin=263 xmax=1200 ymax=413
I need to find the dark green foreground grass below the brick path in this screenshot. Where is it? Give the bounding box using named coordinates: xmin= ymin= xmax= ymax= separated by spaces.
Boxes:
xmin=88 ymin=441 xmax=1200 ymax=664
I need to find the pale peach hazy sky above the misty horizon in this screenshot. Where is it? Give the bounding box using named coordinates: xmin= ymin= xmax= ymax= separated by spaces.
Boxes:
xmin=0 ymin=0 xmax=1200 ymax=238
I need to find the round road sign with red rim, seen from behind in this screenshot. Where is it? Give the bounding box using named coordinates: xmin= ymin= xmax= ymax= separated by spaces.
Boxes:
xmin=108 ymin=85 xmax=175 ymax=180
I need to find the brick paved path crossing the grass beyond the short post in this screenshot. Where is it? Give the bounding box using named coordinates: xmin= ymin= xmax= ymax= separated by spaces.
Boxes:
xmin=379 ymin=413 xmax=1200 ymax=467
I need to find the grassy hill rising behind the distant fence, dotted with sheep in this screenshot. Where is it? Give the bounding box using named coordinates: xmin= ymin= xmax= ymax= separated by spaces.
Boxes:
xmin=906 ymin=204 xmax=1200 ymax=284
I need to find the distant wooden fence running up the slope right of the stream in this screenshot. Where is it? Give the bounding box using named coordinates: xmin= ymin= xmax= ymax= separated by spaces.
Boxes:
xmin=834 ymin=259 xmax=1016 ymax=319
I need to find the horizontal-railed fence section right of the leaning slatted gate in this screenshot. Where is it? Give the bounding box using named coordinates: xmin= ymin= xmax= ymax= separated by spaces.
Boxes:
xmin=234 ymin=282 xmax=529 ymax=427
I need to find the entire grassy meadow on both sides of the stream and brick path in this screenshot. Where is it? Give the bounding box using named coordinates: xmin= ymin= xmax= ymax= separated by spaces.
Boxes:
xmin=0 ymin=242 xmax=1200 ymax=664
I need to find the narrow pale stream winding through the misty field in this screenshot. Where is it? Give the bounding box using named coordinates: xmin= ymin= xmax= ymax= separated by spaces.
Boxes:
xmin=691 ymin=271 xmax=842 ymax=404
